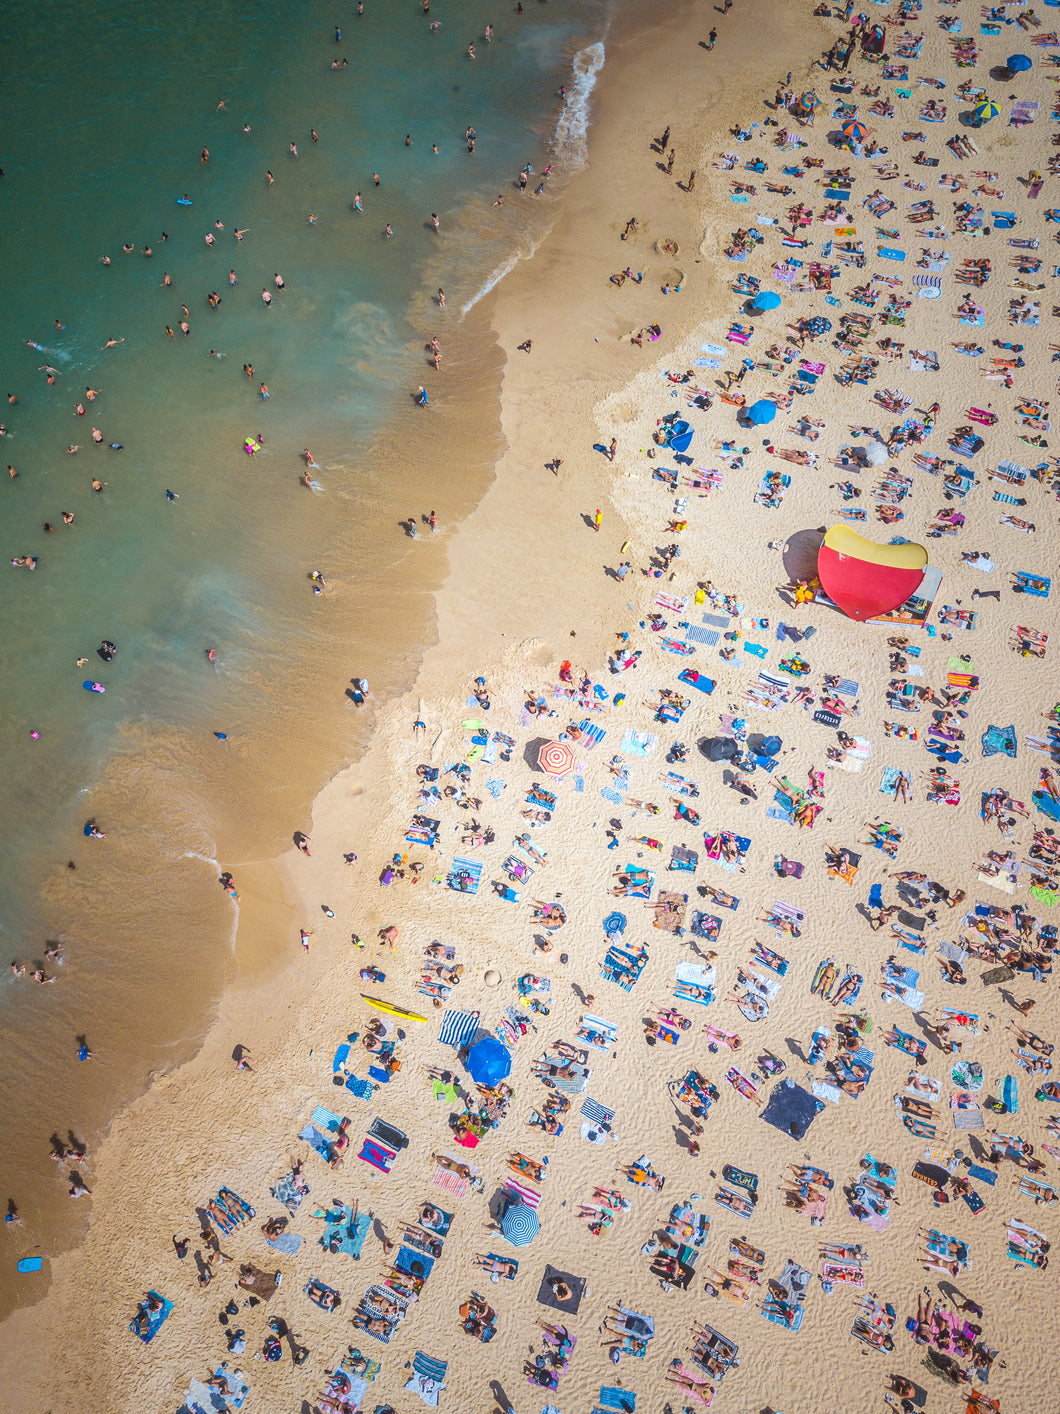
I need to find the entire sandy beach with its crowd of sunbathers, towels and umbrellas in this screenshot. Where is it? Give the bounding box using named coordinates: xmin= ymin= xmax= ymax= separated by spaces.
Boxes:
xmin=0 ymin=0 xmax=1060 ymax=1414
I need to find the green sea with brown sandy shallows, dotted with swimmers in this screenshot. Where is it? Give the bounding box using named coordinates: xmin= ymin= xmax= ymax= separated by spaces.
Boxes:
xmin=0 ymin=0 xmax=609 ymax=1312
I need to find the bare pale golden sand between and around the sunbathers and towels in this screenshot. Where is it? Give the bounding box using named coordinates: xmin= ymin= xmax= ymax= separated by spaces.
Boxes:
xmin=0 ymin=4 xmax=1059 ymax=1414
